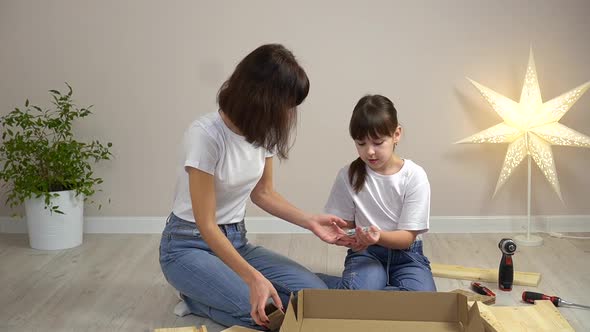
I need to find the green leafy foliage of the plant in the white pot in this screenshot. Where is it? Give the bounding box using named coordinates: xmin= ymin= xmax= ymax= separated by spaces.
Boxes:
xmin=0 ymin=83 xmax=112 ymax=214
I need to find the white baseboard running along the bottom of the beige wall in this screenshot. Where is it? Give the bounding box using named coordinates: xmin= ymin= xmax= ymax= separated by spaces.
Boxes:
xmin=0 ymin=215 xmax=590 ymax=234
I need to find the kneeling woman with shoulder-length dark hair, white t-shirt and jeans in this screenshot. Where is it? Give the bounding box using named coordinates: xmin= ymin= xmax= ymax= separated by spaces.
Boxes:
xmin=160 ymin=44 xmax=347 ymax=329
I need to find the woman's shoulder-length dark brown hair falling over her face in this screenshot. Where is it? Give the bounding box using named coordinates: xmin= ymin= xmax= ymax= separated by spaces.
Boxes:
xmin=217 ymin=44 xmax=309 ymax=159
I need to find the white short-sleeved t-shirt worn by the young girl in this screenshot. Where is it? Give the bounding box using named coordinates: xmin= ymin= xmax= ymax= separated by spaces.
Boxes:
xmin=325 ymin=159 xmax=430 ymax=233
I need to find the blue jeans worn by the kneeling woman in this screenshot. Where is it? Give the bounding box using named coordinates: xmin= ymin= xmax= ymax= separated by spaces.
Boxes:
xmin=160 ymin=214 xmax=327 ymax=329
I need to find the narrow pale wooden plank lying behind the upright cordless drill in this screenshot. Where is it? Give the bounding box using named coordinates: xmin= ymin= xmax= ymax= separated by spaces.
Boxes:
xmin=430 ymin=263 xmax=541 ymax=287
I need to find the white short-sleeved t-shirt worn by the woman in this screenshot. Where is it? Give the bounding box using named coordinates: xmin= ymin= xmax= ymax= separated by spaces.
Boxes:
xmin=172 ymin=112 xmax=272 ymax=225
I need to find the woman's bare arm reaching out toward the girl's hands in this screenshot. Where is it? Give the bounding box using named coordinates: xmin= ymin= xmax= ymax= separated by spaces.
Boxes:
xmin=250 ymin=157 xmax=348 ymax=243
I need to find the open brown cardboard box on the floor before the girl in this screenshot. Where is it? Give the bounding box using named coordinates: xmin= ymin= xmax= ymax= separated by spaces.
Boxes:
xmin=280 ymin=289 xmax=484 ymax=332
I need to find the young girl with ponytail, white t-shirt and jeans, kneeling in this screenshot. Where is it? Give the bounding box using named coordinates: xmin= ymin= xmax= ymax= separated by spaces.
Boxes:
xmin=320 ymin=95 xmax=436 ymax=291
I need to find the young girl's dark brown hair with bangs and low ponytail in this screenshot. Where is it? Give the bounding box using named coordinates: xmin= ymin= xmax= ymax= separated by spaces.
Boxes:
xmin=348 ymin=95 xmax=398 ymax=193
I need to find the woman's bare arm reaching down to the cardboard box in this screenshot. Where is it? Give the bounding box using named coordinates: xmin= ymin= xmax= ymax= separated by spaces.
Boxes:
xmin=187 ymin=167 xmax=282 ymax=326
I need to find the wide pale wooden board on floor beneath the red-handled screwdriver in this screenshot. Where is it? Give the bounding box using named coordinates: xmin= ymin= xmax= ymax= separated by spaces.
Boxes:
xmin=477 ymin=301 xmax=575 ymax=332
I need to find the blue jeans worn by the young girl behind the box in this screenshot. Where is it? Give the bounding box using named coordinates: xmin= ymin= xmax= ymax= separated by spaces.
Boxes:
xmin=318 ymin=240 xmax=436 ymax=292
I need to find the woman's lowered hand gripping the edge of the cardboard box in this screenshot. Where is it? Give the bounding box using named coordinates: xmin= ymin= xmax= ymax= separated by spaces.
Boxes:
xmin=248 ymin=274 xmax=283 ymax=327
